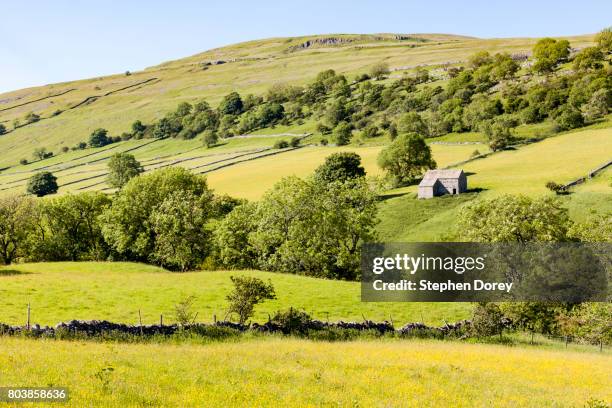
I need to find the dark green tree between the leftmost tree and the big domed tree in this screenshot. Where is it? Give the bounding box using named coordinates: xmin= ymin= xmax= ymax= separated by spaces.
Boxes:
xmin=36 ymin=192 xmax=111 ymax=261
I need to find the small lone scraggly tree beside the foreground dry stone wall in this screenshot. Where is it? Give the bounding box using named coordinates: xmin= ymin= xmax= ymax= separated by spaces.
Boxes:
xmin=226 ymin=276 xmax=276 ymax=324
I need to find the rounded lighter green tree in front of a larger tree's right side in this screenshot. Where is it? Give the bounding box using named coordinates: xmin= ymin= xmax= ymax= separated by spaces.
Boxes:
xmin=150 ymin=190 xmax=211 ymax=271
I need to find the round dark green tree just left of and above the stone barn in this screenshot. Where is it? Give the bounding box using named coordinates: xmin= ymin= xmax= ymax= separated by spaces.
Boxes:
xmin=378 ymin=133 xmax=436 ymax=183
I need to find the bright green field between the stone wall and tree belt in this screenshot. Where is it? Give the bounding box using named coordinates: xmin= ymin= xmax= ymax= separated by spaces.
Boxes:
xmin=0 ymin=262 xmax=471 ymax=325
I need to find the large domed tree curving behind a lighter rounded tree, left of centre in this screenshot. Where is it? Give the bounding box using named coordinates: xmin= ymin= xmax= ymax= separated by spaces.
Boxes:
xmin=101 ymin=167 xmax=212 ymax=262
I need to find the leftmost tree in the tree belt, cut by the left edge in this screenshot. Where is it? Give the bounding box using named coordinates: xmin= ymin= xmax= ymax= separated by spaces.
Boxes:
xmin=0 ymin=196 xmax=36 ymax=265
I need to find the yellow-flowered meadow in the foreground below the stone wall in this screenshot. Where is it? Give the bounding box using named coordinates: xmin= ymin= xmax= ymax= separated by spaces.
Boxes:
xmin=0 ymin=338 xmax=612 ymax=407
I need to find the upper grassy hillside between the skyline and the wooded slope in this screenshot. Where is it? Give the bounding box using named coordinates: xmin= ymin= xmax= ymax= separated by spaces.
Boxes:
xmin=0 ymin=35 xmax=593 ymax=167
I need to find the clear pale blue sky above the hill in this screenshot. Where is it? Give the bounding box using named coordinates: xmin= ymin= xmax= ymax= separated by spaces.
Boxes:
xmin=0 ymin=0 xmax=612 ymax=92
